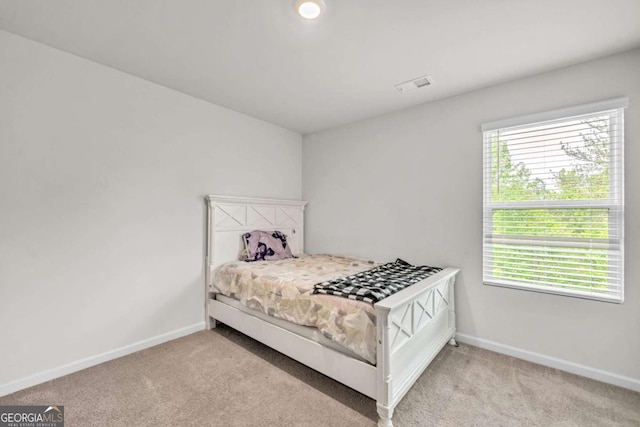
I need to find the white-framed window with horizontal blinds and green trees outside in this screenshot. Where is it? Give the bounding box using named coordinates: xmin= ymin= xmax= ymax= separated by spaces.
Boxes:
xmin=482 ymin=98 xmax=628 ymax=302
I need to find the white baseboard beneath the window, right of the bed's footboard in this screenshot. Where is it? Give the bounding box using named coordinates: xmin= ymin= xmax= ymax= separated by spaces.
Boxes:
xmin=456 ymin=333 xmax=640 ymax=392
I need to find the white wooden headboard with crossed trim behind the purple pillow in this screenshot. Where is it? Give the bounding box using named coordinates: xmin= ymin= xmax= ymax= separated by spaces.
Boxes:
xmin=205 ymin=195 xmax=307 ymax=290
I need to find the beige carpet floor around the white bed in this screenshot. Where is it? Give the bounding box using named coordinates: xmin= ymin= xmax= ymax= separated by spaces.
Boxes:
xmin=0 ymin=326 xmax=640 ymax=427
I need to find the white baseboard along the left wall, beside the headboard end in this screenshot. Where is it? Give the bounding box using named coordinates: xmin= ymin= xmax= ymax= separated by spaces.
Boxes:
xmin=0 ymin=322 xmax=205 ymax=396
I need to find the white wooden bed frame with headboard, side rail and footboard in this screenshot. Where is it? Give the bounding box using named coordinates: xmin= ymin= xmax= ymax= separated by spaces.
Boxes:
xmin=205 ymin=195 xmax=459 ymax=427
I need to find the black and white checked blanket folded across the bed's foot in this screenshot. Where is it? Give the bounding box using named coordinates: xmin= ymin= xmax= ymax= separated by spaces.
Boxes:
xmin=313 ymin=258 xmax=442 ymax=304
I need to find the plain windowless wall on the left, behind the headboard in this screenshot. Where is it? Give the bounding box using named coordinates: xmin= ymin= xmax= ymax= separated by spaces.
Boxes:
xmin=0 ymin=31 xmax=302 ymax=394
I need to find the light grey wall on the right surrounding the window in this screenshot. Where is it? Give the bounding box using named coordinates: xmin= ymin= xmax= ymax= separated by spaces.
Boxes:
xmin=302 ymin=50 xmax=640 ymax=390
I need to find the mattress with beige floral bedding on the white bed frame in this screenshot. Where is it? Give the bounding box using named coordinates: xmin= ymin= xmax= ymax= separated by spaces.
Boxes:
xmin=212 ymin=254 xmax=378 ymax=364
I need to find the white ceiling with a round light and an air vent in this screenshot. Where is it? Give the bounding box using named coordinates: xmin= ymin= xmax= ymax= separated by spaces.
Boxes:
xmin=0 ymin=0 xmax=640 ymax=134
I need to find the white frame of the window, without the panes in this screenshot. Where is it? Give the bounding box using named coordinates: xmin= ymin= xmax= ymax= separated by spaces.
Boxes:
xmin=481 ymin=97 xmax=628 ymax=303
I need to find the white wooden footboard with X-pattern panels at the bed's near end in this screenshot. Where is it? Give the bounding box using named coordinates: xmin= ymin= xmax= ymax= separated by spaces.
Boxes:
xmin=375 ymin=268 xmax=459 ymax=427
